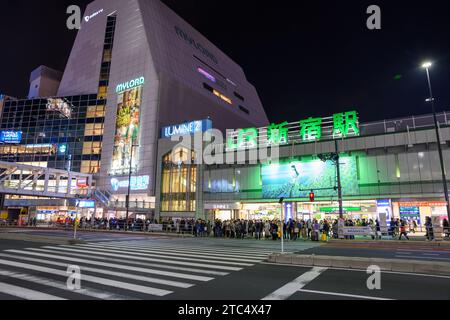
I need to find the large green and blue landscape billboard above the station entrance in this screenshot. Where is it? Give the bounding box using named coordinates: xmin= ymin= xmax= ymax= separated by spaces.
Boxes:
xmin=262 ymin=157 xmax=359 ymax=199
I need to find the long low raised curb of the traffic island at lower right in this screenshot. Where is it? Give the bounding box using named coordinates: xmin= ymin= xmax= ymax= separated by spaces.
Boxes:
xmin=268 ymin=253 xmax=450 ymax=276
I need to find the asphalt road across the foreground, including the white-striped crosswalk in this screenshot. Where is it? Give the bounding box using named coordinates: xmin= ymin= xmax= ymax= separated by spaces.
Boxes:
xmin=0 ymin=235 xmax=450 ymax=303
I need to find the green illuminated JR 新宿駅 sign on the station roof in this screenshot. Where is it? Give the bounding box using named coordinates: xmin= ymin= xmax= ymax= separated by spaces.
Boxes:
xmin=227 ymin=111 xmax=360 ymax=150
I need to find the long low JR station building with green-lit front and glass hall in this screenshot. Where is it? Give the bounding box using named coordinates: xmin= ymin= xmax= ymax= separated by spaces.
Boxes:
xmin=157 ymin=112 xmax=450 ymax=225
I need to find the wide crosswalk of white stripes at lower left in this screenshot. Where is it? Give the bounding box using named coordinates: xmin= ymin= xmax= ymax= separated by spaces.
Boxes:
xmin=0 ymin=240 xmax=278 ymax=300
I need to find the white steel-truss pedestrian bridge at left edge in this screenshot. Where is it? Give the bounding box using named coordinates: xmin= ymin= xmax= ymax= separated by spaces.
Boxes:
xmin=0 ymin=161 xmax=93 ymax=199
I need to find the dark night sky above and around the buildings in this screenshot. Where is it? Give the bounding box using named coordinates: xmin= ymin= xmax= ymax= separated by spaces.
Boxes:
xmin=0 ymin=0 xmax=450 ymax=122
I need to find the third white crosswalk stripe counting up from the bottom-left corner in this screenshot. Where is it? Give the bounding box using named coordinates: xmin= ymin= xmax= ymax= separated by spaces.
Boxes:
xmin=0 ymin=259 xmax=173 ymax=297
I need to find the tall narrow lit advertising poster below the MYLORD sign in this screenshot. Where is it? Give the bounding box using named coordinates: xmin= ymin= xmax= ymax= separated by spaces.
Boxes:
xmin=111 ymin=86 xmax=142 ymax=174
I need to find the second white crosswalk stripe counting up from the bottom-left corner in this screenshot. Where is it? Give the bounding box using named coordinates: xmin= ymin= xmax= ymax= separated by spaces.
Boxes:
xmin=0 ymin=270 xmax=131 ymax=300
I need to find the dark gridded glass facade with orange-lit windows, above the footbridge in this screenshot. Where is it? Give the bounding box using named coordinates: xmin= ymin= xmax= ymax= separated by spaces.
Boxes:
xmin=0 ymin=94 xmax=106 ymax=174
